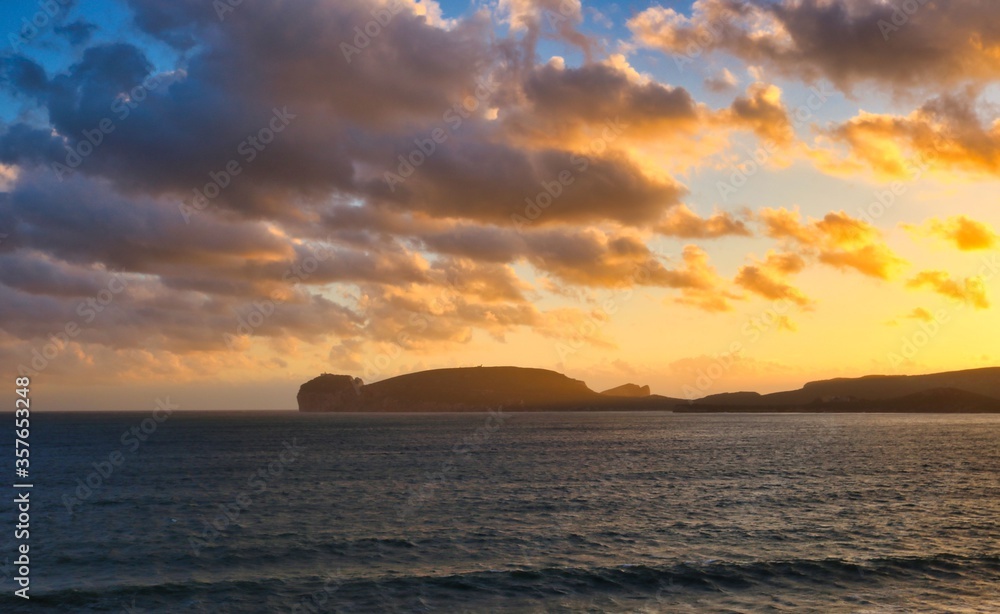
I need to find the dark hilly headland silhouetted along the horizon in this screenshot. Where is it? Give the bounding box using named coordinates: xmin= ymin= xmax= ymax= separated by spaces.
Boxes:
xmin=297 ymin=367 xmax=1000 ymax=413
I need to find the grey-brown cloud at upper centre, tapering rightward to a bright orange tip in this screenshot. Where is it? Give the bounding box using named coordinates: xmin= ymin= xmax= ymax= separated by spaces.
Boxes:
xmin=497 ymin=60 xmax=794 ymax=176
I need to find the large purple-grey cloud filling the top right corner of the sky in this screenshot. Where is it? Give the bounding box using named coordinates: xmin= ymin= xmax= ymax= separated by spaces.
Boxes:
xmin=628 ymin=0 xmax=1000 ymax=92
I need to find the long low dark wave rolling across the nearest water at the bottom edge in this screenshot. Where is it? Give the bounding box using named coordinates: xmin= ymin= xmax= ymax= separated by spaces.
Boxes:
xmin=32 ymin=554 xmax=1000 ymax=610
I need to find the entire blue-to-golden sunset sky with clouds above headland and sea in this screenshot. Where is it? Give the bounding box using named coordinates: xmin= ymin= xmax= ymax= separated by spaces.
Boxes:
xmin=0 ymin=0 xmax=1000 ymax=410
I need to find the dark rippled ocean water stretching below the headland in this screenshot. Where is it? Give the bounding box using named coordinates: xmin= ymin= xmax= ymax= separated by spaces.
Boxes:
xmin=0 ymin=412 xmax=1000 ymax=613
